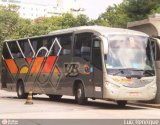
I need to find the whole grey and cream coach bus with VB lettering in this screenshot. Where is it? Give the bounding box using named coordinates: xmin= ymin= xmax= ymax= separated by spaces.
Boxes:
xmin=1 ymin=26 xmax=157 ymax=106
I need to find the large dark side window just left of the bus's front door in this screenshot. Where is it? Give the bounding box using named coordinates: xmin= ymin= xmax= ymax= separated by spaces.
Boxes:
xmin=74 ymin=33 xmax=92 ymax=61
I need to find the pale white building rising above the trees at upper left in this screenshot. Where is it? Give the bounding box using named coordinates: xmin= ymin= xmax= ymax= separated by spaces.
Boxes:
xmin=0 ymin=0 xmax=84 ymax=19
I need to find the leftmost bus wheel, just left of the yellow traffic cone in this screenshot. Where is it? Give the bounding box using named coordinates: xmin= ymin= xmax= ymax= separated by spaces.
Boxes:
xmin=17 ymin=81 xmax=27 ymax=99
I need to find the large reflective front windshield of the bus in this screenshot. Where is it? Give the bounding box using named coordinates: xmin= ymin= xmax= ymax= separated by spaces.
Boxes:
xmin=106 ymin=35 xmax=154 ymax=75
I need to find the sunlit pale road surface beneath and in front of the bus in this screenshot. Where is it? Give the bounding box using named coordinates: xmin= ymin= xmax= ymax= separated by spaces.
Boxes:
xmin=0 ymin=90 xmax=160 ymax=119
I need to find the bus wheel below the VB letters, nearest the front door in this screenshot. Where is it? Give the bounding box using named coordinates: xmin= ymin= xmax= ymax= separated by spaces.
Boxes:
xmin=75 ymin=84 xmax=87 ymax=105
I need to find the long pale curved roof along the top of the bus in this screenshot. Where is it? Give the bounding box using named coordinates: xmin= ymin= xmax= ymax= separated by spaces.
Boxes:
xmin=5 ymin=26 xmax=148 ymax=42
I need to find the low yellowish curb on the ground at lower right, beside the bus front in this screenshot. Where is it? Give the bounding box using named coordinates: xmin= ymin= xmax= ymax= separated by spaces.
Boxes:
xmin=128 ymin=102 xmax=160 ymax=109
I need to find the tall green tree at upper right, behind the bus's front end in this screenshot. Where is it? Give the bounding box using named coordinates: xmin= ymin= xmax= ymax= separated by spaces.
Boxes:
xmin=97 ymin=0 xmax=160 ymax=27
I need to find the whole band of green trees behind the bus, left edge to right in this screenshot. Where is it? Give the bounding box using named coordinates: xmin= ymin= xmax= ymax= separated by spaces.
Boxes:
xmin=0 ymin=0 xmax=160 ymax=50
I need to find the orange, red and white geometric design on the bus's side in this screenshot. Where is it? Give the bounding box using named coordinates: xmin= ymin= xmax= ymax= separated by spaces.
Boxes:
xmin=2 ymin=38 xmax=62 ymax=90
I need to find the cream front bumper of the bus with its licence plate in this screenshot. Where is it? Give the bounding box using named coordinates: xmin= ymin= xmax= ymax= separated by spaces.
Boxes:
xmin=103 ymin=83 xmax=157 ymax=101
